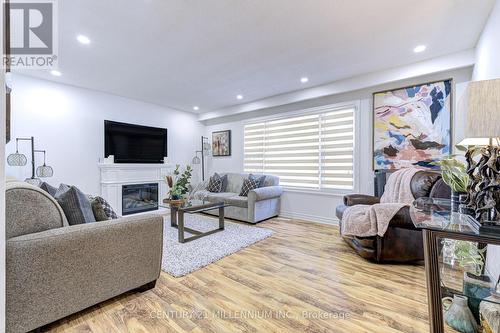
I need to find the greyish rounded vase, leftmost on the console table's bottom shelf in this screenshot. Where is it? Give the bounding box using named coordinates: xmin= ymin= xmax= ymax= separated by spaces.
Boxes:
xmin=443 ymin=295 xmax=479 ymax=333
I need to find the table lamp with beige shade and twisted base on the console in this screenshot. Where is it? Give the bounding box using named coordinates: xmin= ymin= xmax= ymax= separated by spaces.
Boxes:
xmin=458 ymin=79 xmax=500 ymax=226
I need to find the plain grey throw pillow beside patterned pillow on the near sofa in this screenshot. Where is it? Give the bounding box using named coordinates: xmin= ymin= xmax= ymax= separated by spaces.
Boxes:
xmin=56 ymin=186 xmax=95 ymax=225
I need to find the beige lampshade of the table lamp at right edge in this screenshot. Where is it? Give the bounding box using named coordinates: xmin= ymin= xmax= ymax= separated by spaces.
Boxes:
xmin=461 ymin=79 xmax=500 ymax=138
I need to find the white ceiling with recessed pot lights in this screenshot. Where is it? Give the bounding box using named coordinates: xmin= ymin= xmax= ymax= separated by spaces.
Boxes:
xmin=16 ymin=0 xmax=494 ymax=113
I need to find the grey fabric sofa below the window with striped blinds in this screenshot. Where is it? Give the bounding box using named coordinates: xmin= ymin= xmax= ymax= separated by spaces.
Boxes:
xmin=193 ymin=173 xmax=283 ymax=223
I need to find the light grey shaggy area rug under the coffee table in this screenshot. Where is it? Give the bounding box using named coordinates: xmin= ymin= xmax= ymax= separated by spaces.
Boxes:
xmin=162 ymin=214 xmax=274 ymax=277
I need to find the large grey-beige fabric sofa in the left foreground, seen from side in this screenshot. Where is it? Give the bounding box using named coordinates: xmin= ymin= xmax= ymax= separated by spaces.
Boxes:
xmin=6 ymin=183 xmax=163 ymax=333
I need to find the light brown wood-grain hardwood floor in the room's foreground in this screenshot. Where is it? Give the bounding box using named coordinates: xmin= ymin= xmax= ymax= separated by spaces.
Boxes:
xmin=46 ymin=219 xmax=451 ymax=333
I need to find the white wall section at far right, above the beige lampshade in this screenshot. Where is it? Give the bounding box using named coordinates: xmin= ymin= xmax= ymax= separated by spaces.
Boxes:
xmin=472 ymin=0 xmax=500 ymax=81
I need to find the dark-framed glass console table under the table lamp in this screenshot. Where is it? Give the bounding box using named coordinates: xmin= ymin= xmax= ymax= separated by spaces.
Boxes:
xmin=410 ymin=198 xmax=500 ymax=333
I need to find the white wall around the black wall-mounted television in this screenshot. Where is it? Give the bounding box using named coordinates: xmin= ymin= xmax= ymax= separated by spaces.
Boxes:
xmin=6 ymin=75 xmax=204 ymax=194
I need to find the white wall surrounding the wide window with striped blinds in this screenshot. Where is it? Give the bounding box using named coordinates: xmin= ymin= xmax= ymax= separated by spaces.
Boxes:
xmin=205 ymin=67 xmax=472 ymax=223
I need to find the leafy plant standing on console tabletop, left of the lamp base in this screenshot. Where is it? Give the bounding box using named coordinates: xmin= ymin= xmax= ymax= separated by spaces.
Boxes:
xmin=433 ymin=155 xmax=469 ymax=212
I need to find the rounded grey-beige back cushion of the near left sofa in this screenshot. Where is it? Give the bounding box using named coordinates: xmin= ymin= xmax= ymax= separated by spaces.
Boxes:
xmin=5 ymin=182 xmax=68 ymax=239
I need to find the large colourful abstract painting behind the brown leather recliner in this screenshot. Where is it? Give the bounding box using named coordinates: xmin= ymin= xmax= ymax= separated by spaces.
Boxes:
xmin=373 ymin=80 xmax=452 ymax=170
